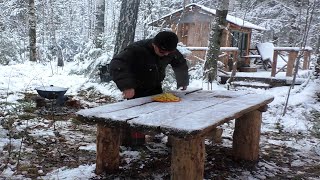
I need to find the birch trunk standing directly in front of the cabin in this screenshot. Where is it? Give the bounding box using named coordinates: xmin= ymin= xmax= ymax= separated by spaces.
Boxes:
xmin=204 ymin=0 xmax=229 ymax=89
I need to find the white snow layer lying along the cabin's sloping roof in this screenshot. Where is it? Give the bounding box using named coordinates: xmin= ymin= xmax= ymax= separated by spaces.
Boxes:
xmin=149 ymin=3 xmax=267 ymax=31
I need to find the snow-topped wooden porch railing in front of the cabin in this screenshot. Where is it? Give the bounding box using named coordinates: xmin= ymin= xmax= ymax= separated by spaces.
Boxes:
xmin=186 ymin=47 xmax=312 ymax=77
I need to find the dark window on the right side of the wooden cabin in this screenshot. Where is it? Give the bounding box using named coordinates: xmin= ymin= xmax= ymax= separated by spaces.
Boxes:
xmin=231 ymin=31 xmax=249 ymax=56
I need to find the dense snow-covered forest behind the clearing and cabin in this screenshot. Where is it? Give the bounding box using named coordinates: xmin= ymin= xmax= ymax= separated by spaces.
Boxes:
xmin=0 ymin=0 xmax=320 ymax=70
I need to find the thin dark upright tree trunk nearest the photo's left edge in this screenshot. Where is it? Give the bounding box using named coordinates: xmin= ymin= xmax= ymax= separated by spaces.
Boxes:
xmin=29 ymin=0 xmax=37 ymax=61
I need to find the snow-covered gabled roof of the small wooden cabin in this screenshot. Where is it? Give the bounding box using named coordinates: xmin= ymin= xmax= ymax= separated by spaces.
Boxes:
xmin=149 ymin=3 xmax=266 ymax=31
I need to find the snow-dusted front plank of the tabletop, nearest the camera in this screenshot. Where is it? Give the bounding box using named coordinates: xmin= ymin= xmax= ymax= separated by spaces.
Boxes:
xmin=129 ymin=94 xmax=273 ymax=134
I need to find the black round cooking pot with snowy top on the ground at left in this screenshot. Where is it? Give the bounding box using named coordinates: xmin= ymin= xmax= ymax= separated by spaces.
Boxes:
xmin=35 ymin=85 xmax=68 ymax=99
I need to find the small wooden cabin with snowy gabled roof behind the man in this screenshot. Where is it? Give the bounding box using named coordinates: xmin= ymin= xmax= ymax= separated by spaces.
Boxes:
xmin=149 ymin=3 xmax=265 ymax=69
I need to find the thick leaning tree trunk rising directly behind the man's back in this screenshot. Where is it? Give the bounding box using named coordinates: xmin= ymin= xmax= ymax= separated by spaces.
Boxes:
xmin=114 ymin=0 xmax=140 ymax=54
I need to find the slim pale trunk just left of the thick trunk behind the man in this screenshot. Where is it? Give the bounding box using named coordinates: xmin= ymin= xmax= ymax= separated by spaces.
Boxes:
xmin=94 ymin=0 xmax=106 ymax=48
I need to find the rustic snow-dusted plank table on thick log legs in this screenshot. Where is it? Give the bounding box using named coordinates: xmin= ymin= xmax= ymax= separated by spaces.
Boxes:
xmin=77 ymin=90 xmax=273 ymax=180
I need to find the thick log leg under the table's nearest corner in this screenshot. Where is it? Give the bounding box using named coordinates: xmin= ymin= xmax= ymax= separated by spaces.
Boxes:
xmin=171 ymin=137 xmax=205 ymax=180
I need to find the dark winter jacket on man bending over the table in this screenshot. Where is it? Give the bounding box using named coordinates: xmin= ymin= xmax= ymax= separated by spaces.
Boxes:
xmin=110 ymin=39 xmax=189 ymax=98
